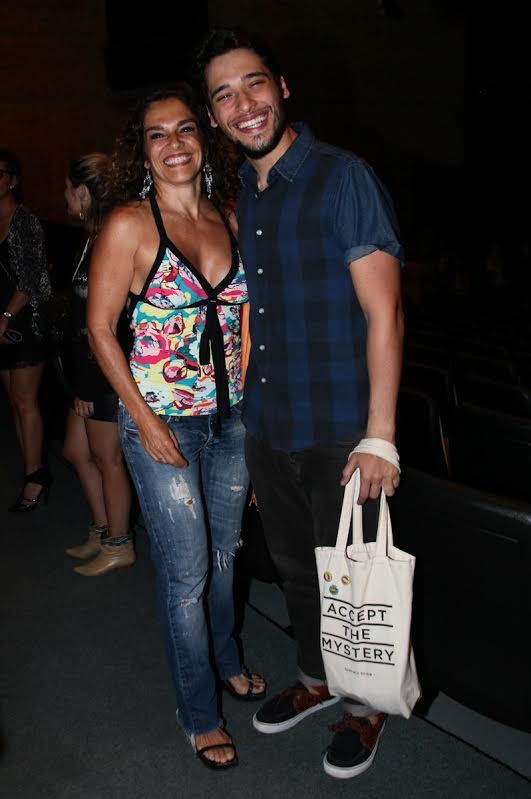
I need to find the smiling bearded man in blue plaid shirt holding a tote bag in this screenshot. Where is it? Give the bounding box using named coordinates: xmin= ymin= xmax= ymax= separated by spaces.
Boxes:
xmin=197 ymin=30 xmax=403 ymax=778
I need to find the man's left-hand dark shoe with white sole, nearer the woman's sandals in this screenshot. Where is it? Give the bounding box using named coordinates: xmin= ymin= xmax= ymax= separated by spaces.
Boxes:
xmin=253 ymin=682 xmax=340 ymax=733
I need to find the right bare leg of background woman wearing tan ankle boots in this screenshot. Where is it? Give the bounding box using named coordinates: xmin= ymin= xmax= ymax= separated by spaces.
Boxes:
xmin=85 ymin=419 xmax=131 ymax=538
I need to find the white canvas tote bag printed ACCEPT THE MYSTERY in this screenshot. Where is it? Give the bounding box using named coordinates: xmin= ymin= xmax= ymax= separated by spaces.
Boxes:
xmin=315 ymin=469 xmax=420 ymax=718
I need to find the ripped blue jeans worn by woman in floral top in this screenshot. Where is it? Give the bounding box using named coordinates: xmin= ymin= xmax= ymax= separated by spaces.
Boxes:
xmin=118 ymin=403 xmax=249 ymax=743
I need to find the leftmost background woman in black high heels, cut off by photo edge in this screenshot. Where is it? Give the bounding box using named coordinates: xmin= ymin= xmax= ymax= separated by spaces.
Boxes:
xmin=0 ymin=149 xmax=52 ymax=513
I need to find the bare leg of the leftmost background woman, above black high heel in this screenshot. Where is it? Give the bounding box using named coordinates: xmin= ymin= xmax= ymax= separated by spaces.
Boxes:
xmin=9 ymin=363 xmax=44 ymax=499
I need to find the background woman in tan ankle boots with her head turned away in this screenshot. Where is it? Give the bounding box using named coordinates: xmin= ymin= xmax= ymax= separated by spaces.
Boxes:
xmin=63 ymin=153 xmax=135 ymax=577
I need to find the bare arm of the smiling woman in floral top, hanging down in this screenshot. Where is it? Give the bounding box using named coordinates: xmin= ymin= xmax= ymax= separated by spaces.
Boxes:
xmin=87 ymin=208 xmax=186 ymax=466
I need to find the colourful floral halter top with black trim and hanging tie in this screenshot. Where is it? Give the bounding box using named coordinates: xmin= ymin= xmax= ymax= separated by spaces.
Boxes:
xmin=129 ymin=194 xmax=249 ymax=419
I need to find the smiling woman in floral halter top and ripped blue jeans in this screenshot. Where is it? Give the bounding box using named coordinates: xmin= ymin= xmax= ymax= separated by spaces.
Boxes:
xmin=88 ymin=84 xmax=266 ymax=770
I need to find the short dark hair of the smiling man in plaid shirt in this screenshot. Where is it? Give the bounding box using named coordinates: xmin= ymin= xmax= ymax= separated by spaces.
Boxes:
xmin=195 ymin=28 xmax=282 ymax=108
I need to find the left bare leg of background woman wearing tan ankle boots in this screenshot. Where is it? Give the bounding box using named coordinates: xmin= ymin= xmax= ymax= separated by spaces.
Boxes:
xmin=63 ymin=409 xmax=107 ymax=527
